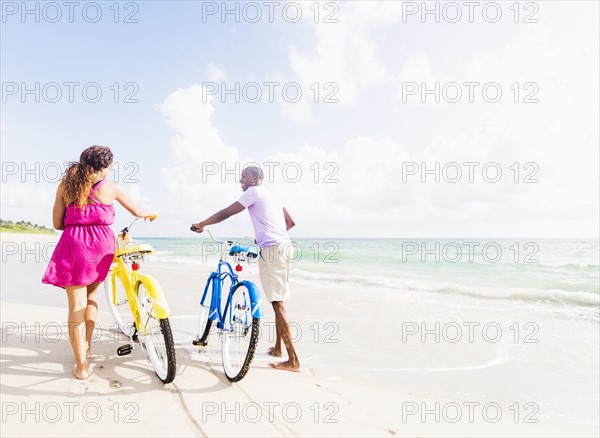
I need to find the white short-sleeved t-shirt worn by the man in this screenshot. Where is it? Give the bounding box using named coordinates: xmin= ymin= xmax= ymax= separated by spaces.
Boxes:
xmin=238 ymin=186 xmax=290 ymax=249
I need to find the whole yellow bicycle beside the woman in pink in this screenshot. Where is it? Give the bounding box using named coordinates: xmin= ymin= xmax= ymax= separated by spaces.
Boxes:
xmin=104 ymin=219 xmax=177 ymax=383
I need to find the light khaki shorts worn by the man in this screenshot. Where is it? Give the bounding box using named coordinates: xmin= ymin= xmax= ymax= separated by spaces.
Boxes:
xmin=258 ymin=243 xmax=294 ymax=303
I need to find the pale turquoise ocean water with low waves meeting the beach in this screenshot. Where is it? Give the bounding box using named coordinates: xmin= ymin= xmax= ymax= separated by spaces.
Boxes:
xmin=137 ymin=237 xmax=600 ymax=314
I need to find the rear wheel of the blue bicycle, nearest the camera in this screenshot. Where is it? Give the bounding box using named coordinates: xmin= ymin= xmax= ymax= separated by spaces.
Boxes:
xmin=221 ymin=283 xmax=260 ymax=382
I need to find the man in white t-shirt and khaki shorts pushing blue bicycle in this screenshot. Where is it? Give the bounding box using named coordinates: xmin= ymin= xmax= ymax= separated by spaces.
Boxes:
xmin=192 ymin=166 xmax=300 ymax=371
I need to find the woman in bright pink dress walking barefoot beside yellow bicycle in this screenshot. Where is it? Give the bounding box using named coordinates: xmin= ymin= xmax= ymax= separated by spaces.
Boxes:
xmin=42 ymin=146 xmax=155 ymax=379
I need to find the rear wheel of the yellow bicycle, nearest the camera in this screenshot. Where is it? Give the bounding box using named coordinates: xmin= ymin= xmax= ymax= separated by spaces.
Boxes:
xmin=137 ymin=282 xmax=177 ymax=383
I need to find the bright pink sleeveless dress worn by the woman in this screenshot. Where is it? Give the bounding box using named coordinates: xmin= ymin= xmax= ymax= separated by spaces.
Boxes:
xmin=42 ymin=179 xmax=116 ymax=288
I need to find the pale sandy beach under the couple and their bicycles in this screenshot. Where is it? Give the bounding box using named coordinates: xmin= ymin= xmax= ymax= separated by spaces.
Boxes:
xmin=1 ymin=233 xmax=600 ymax=437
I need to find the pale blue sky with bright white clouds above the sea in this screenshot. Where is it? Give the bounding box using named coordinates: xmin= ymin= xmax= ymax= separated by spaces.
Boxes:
xmin=0 ymin=1 xmax=599 ymax=237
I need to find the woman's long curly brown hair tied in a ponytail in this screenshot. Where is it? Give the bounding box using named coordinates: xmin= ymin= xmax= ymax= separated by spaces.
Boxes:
xmin=58 ymin=145 xmax=113 ymax=207
